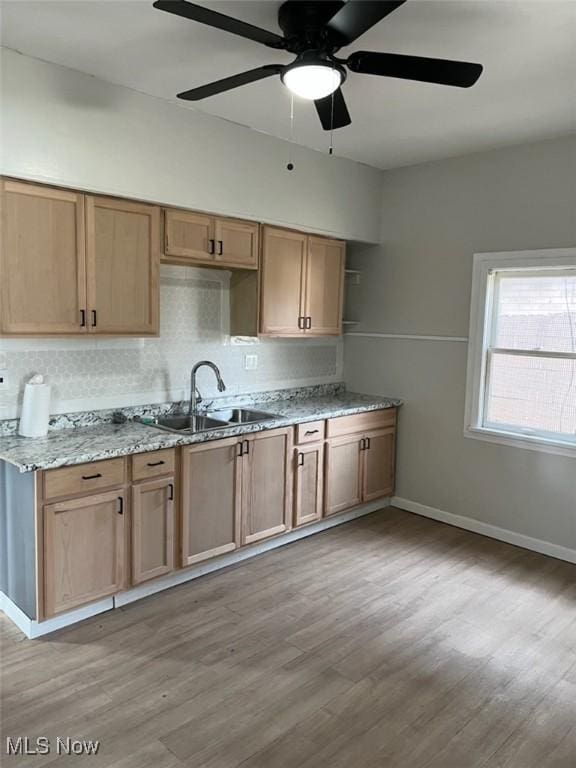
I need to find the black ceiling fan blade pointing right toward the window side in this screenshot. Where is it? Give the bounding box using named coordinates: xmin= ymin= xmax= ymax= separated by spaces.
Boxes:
xmin=346 ymin=51 xmax=483 ymax=88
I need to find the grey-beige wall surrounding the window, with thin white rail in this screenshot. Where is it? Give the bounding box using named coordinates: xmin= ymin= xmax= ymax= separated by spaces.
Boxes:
xmin=345 ymin=136 xmax=576 ymax=550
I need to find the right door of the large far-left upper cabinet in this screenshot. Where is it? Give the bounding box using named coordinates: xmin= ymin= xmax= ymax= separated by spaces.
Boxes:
xmin=86 ymin=197 xmax=160 ymax=336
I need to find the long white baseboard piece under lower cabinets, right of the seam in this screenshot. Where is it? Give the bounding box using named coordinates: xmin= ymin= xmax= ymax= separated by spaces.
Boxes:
xmin=114 ymin=498 xmax=390 ymax=608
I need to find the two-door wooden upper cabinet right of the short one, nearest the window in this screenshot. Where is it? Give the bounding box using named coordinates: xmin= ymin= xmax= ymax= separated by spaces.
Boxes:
xmin=260 ymin=227 xmax=345 ymax=336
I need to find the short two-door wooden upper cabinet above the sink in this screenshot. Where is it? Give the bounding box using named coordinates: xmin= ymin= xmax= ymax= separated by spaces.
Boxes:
xmin=162 ymin=208 xmax=260 ymax=269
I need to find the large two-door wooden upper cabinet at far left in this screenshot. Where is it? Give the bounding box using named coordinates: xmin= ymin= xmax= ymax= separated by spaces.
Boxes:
xmin=0 ymin=179 xmax=160 ymax=336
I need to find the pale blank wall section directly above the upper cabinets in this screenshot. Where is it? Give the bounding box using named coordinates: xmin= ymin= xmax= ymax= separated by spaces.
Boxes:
xmin=0 ymin=49 xmax=382 ymax=243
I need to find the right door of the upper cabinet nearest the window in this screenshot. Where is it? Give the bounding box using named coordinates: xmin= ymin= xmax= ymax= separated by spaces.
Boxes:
xmin=304 ymin=237 xmax=346 ymax=336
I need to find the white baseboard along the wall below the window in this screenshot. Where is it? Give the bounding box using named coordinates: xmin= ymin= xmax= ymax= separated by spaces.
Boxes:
xmin=391 ymin=496 xmax=576 ymax=563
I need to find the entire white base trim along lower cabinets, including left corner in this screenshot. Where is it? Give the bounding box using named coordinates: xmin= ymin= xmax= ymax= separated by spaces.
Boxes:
xmin=0 ymin=498 xmax=390 ymax=640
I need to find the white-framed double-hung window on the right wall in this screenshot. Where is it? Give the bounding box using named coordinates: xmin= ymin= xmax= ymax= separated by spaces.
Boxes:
xmin=465 ymin=249 xmax=576 ymax=455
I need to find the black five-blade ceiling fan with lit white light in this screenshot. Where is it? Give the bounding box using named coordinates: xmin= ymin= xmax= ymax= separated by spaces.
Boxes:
xmin=154 ymin=0 xmax=482 ymax=131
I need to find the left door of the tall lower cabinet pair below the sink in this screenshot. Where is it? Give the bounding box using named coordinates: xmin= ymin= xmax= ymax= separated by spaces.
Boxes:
xmin=181 ymin=438 xmax=242 ymax=566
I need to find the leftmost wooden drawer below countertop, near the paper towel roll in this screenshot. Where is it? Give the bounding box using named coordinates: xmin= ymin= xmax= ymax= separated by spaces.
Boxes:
xmin=44 ymin=458 xmax=125 ymax=499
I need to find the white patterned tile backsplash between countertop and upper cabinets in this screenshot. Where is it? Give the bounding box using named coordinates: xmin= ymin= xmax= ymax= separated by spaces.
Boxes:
xmin=0 ymin=265 xmax=342 ymax=419
